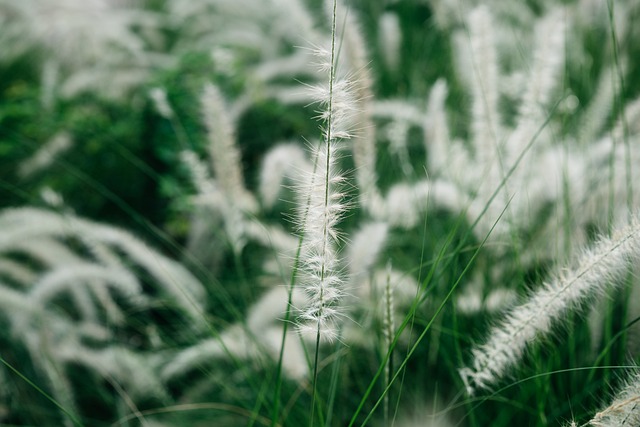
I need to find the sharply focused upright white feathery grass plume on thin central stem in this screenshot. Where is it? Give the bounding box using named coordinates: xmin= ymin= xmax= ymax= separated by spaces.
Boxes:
xmin=297 ymin=1 xmax=356 ymax=343
